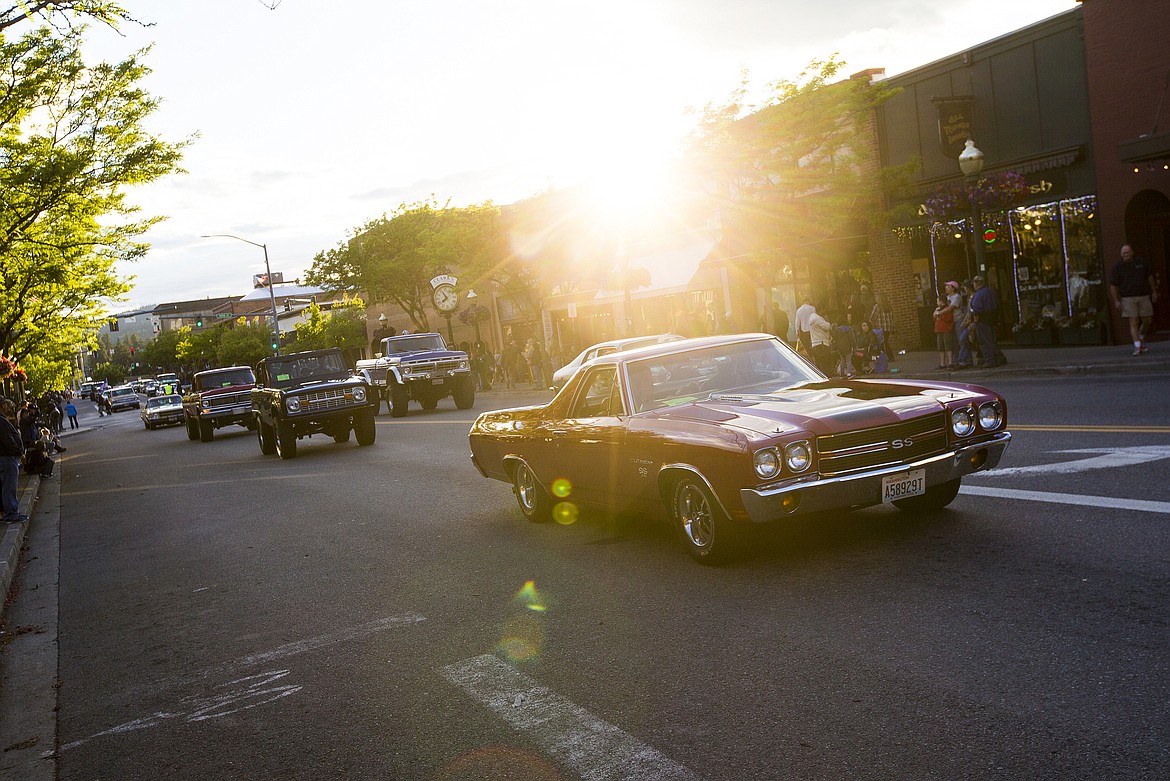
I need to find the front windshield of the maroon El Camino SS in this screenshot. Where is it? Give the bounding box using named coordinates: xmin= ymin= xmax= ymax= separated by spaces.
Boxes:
xmin=627 ymin=339 xmax=824 ymax=412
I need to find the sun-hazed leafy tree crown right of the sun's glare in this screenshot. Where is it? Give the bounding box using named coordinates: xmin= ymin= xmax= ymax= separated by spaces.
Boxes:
xmin=691 ymin=55 xmax=917 ymax=271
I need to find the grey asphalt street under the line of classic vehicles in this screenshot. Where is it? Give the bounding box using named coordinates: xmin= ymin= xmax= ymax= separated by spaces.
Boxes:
xmin=2 ymin=376 xmax=1170 ymax=781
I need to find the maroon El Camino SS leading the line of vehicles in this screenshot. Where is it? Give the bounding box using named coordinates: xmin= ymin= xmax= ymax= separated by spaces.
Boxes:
xmin=468 ymin=333 xmax=1011 ymax=562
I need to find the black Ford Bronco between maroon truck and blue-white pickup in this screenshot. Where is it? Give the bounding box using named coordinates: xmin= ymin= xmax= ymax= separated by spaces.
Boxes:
xmin=252 ymin=347 xmax=378 ymax=458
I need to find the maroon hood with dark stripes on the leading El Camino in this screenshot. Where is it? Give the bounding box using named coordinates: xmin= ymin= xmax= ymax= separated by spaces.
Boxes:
xmin=660 ymin=380 xmax=977 ymax=435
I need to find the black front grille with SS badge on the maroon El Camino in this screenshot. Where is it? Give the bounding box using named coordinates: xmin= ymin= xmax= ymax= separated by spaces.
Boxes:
xmin=817 ymin=413 xmax=947 ymax=476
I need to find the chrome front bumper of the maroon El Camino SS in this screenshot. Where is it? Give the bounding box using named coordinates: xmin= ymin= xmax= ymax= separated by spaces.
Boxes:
xmin=739 ymin=431 xmax=1012 ymax=524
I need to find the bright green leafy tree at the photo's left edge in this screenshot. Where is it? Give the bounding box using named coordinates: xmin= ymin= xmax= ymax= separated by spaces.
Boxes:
xmin=0 ymin=28 xmax=186 ymax=371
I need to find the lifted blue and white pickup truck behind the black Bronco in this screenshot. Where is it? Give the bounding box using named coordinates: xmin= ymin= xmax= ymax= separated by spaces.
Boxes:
xmin=356 ymin=333 xmax=475 ymax=417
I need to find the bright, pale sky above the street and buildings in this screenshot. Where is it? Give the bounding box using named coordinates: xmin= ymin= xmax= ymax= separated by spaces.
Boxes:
xmin=85 ymin=0 xmax=1076 ymax=312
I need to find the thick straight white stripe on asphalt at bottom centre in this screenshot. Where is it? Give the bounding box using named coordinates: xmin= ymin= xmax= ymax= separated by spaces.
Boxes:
xmin=441 ymin=654 xmax=700 ymax=781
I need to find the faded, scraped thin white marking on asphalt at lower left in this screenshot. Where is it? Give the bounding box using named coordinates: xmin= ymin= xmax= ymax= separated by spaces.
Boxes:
xmin=58 ymin=613 xmax=426 ymax=754
